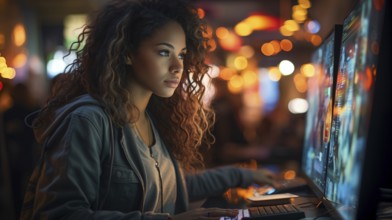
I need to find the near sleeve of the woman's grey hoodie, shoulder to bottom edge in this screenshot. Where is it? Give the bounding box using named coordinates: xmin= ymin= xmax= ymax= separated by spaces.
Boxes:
xmin=33 ymin=110 xmax=167 ymax=220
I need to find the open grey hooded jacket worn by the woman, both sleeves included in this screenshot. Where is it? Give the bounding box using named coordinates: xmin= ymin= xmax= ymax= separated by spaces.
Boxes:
xmin=21 ymin=95 xmax=252 ymax=220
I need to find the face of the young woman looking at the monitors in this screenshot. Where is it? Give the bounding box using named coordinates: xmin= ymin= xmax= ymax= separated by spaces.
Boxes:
xmin=131 ymin=22 xmax=186 ymax=97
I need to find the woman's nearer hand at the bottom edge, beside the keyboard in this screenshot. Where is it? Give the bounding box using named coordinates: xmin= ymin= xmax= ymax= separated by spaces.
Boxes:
xmin=169 ymin=208 xmax=238 ymax=220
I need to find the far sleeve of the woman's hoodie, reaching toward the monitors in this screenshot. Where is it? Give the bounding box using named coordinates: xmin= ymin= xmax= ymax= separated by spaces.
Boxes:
xmin=185 ymin=166 xmax=253 ymax=201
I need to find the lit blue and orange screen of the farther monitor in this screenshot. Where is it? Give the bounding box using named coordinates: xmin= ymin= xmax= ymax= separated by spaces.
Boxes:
xmin=302 ymin=25 xmax=342 ymax=193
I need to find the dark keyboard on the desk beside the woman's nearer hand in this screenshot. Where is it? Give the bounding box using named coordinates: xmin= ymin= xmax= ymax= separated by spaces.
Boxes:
xmin=220 ymin=204 xmax=305 ymax=220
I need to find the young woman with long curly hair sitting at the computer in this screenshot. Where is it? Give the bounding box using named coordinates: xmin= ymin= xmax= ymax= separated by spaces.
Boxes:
xmin=21 ymin=0 xmax=272 ymax=219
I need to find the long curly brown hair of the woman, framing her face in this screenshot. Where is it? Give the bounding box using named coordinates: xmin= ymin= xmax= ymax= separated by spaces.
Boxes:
xmin=35 ymin=0 xmax=214 ymax=170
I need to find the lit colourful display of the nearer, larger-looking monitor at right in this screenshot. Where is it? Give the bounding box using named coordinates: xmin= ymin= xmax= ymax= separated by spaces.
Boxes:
xmin=325 ymin=0 xmax=382 ymax=219
